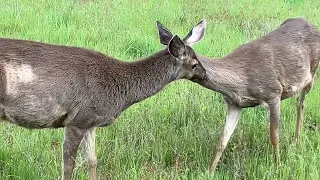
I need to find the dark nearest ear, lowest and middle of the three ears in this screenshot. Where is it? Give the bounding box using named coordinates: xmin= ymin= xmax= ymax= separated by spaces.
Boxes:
xmin=168 ymin=35 xmax=186 ymax=59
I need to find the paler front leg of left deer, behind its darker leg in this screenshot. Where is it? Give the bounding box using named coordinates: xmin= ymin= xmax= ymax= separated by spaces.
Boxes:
xmin=82 ymin=128 xmax=97 ymax=180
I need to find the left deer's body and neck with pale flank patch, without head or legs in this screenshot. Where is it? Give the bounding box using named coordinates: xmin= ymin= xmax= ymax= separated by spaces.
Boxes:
xmin=0 ymin=39 xmax=177 ymax=128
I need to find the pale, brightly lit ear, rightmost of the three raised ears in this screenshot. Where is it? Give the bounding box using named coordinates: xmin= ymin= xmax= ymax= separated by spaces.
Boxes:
xmin=183 ymin=19 xmax=207 ymax=46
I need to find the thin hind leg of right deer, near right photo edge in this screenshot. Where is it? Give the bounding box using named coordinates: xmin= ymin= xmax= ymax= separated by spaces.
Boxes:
xmin=295 ymin=81 xmax=313 ymax=140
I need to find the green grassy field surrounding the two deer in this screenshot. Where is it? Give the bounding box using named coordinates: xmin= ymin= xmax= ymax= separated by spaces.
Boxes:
xmin=0 ymin=0 xmax=320 ymax=180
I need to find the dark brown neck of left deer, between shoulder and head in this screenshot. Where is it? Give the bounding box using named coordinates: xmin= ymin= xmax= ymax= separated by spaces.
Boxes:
xmin=125 ymin=50 xmax=178 ymax=104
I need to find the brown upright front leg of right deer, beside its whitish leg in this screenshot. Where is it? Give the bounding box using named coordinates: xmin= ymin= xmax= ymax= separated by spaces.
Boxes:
xmin=267 ymin=97 xmax=281 ymax=165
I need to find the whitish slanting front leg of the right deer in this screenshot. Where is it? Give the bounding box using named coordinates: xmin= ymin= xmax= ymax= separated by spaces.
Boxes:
xmin=210 ymin=104 xmax=241 ymax=173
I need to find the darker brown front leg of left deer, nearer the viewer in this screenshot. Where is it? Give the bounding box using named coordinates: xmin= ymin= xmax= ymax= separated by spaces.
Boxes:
xmin=62 ymin=127 xmax=86 ymax=180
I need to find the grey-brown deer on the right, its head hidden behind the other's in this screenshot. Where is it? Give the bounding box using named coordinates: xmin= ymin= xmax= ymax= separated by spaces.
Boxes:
xmin=162 ymin=18 xmax=320 ymax=172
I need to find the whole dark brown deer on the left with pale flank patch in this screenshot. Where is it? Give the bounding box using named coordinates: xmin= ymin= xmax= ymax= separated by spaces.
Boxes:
xmin=0 ymin=22 xmax=205 ymax=179
